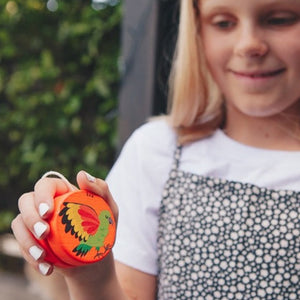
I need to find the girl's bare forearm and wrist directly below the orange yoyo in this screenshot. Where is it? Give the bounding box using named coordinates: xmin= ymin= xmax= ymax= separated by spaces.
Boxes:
xmin=65 ymin=254 xmax=129 ymax=300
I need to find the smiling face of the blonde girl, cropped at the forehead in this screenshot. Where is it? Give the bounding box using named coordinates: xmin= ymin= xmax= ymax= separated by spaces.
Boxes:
xmin=199 ymin=0 xmax=300 ymax=117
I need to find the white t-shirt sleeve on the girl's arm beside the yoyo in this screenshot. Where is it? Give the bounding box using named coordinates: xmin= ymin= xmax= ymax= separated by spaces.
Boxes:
xmin=106 ymin=122 xmax=175 ymax=275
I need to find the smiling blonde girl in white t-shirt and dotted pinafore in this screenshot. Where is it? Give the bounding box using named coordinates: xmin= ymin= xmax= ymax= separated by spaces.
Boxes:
xmin=12 ymin=0 xmax=300 ymax=300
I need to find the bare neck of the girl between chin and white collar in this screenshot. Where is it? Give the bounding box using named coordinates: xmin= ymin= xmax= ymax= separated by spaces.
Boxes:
xmin=224 ymin=106 xmax=300 ymax=151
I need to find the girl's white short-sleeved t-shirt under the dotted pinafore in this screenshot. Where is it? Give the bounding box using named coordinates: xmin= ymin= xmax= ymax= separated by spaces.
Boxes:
xmin=107 ymin=120 xmax=300 ymax=275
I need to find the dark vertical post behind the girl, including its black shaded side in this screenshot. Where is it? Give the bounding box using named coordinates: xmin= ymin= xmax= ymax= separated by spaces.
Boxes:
xmin=118 ymin=0 xmax=178 ymax=147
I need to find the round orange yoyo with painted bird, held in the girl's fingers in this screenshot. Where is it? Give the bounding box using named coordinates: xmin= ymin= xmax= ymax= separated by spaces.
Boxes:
xmin=38 ymin=190 xmax=116 ymax=267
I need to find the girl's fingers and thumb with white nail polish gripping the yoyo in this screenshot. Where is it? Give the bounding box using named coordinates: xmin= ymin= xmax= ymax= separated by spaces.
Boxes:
xmin=11 ymin=171 xmax=118 ymax=275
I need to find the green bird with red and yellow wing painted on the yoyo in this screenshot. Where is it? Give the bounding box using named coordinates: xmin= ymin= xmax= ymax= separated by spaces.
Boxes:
xmin=59 ymin=202 xmax=113 ymax=258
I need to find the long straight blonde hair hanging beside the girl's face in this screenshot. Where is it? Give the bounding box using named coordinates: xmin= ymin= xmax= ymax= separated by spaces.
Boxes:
xmin=168 ymin=0 xmax=224 ymax=144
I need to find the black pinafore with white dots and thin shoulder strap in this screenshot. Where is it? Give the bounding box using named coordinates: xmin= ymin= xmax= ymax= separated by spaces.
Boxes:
xmin=158 ymin=147 xmax=300 ymax=300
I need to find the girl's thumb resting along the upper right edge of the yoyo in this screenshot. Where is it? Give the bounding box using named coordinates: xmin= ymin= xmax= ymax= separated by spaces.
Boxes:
xmin=77 ymin=171 xmax=118 ymax=220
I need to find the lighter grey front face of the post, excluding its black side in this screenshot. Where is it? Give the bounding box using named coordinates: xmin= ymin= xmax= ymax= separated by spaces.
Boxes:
xmin=118 ymin=0 xmax=159 ymax=145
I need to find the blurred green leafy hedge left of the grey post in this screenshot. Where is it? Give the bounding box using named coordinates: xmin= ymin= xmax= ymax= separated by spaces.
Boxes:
xmin=0 ymin=0 xmax=121 ymax=224
